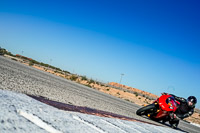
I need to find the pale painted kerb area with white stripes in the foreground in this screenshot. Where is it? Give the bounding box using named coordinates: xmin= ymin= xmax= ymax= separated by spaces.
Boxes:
xmin=0 ymin=90 xmax=182 ymax=133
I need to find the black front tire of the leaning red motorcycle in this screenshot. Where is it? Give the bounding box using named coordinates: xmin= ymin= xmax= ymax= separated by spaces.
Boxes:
xmin=136 ymin=104 xmax=156 ymax=116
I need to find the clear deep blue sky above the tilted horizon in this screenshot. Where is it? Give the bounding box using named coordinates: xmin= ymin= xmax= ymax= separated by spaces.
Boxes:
xmin=0 ymin=0 xmax=200 ymax=108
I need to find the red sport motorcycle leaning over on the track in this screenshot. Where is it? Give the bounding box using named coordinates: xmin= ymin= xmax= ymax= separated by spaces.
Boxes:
xmin=136 ymin=94 xmax=177 ymax=121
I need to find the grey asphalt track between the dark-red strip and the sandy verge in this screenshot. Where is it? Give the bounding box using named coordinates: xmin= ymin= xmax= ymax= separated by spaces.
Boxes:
xmin=0 ymin=56 xmax=200 ymax=133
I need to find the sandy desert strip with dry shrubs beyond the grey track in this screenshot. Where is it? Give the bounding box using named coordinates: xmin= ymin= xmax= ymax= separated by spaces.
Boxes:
xmin=4 ymin=55 xmax=200 ymax=124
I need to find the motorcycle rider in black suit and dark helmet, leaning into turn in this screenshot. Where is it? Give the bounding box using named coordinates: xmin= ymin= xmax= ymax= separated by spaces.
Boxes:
xmin=164 ymin=93 xmax=197 ymax=128
